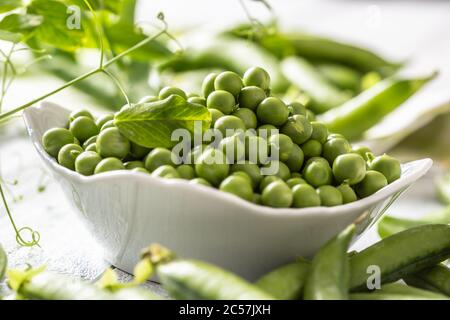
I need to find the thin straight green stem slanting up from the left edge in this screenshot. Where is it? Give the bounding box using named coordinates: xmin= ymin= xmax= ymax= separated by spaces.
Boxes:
xmin=0 ymin=24 xmax=167 ymax=120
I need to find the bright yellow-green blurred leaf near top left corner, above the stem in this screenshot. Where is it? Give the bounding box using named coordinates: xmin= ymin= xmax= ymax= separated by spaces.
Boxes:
xmin=28 ymin=0 xmax=85 ymax=51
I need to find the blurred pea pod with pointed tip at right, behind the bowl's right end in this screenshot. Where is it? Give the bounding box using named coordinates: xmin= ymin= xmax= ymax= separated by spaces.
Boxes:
xmin=318 ymin=74 xmax=435 ymax=140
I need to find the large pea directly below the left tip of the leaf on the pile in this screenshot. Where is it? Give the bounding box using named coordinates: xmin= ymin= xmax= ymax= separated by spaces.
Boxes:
xmin=97 ymin=128 xmax=130 ymax=159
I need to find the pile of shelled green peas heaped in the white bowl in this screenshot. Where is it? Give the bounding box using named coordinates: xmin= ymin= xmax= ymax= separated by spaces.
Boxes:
xmin=42 ymin=67 xmax=401 ymax=208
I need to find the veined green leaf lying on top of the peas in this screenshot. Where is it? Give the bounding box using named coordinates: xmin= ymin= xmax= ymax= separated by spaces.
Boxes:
xmin=114 ymin=95 xmax=211 ymax=148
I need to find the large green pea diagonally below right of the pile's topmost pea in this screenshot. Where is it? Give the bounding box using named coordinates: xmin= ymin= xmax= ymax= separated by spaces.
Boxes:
xmin=256 ymin=97 xmax=289 ymax=126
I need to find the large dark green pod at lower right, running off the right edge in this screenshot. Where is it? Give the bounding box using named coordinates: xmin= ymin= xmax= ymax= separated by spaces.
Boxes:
xmin=350 ymin=224 xmax=450 ymax=291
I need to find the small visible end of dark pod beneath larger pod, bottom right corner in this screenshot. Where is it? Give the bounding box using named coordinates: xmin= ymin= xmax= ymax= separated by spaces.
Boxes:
xmin=403 ymin=264 xmax=450 ymax=296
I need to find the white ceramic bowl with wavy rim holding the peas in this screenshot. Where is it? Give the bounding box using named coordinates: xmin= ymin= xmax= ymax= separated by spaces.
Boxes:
xmin=24 ymin=102 xmax=432 ymax=280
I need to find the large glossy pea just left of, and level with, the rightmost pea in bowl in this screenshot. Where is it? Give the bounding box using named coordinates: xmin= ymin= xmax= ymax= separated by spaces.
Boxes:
xmin=333 ymin=153 xmax=366 ymax=185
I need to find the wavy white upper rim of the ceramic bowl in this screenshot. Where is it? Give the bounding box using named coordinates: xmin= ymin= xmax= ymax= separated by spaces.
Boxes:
xmin=23 ymin=101 xmax=433 ymax=219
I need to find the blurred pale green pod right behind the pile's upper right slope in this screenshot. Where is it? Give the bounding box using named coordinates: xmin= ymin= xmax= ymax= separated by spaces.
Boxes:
xmin=281 ymin=57 xmax=351 ymax=113
